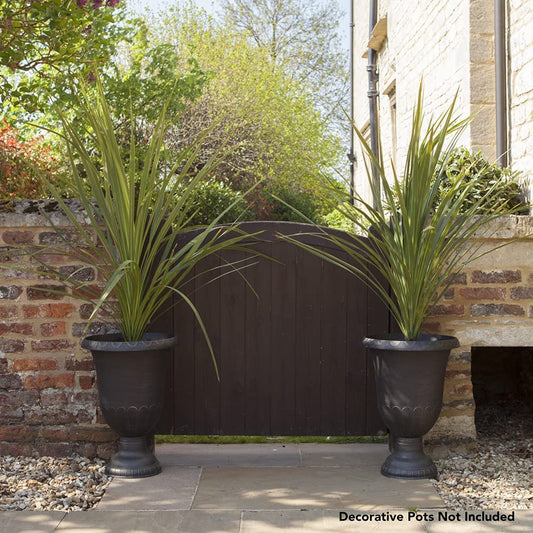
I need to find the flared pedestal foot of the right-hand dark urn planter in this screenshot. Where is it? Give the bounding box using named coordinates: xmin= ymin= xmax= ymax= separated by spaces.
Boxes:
xmin=381 ymin=437 xmax=437 ymax=479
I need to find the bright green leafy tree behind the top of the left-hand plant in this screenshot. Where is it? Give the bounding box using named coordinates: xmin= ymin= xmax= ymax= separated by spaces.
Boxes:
xmin=3 ymin=2 xmax=207 ymax=181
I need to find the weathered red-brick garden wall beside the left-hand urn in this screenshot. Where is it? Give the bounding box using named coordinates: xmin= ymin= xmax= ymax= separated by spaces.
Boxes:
xmin=0 ymin=202 xmax=116 ymax=457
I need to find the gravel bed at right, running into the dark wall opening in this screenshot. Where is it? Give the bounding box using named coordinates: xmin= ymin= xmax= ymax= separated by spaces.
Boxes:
xmin=434 ymin=404 xmax=533 ymax=510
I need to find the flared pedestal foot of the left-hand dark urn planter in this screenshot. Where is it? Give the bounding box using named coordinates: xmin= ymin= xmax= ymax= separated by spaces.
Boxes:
xmin=105 ymin=435 xmax=161 ymax=477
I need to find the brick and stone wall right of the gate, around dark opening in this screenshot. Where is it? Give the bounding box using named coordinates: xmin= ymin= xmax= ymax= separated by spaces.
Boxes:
xmin=425 ymin=216 xmax=533 ymax=453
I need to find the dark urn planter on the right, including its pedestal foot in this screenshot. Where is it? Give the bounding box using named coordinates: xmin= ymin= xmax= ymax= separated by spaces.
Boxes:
xmin=363 ymin=334 xmax=459 ymax=479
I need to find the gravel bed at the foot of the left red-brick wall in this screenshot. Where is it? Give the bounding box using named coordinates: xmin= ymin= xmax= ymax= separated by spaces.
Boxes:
xmin=0 ymin=456 xmax=111 ymax=511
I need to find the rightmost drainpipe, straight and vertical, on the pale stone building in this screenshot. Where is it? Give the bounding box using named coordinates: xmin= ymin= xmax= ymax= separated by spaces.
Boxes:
xmin=494 ymin=0 xmax=509 ymax=167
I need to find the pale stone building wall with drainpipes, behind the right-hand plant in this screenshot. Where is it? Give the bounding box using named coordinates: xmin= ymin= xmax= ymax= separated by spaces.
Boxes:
xmin=354 ymin=0 xmax=533 ymax=206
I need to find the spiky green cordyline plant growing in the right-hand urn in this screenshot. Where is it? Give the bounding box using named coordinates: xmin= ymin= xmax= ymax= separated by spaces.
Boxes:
xmin=281 ymin=86 xmax=516 ymax=340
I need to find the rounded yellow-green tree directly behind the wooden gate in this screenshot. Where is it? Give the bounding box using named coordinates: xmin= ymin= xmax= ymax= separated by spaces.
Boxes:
xmin=143 ymin=4 xmax=338 ymax=219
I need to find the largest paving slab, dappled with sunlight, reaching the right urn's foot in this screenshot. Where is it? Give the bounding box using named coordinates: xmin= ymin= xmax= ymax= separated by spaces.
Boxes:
xmin=192 ymin=465 xmax=444 ymax=510
